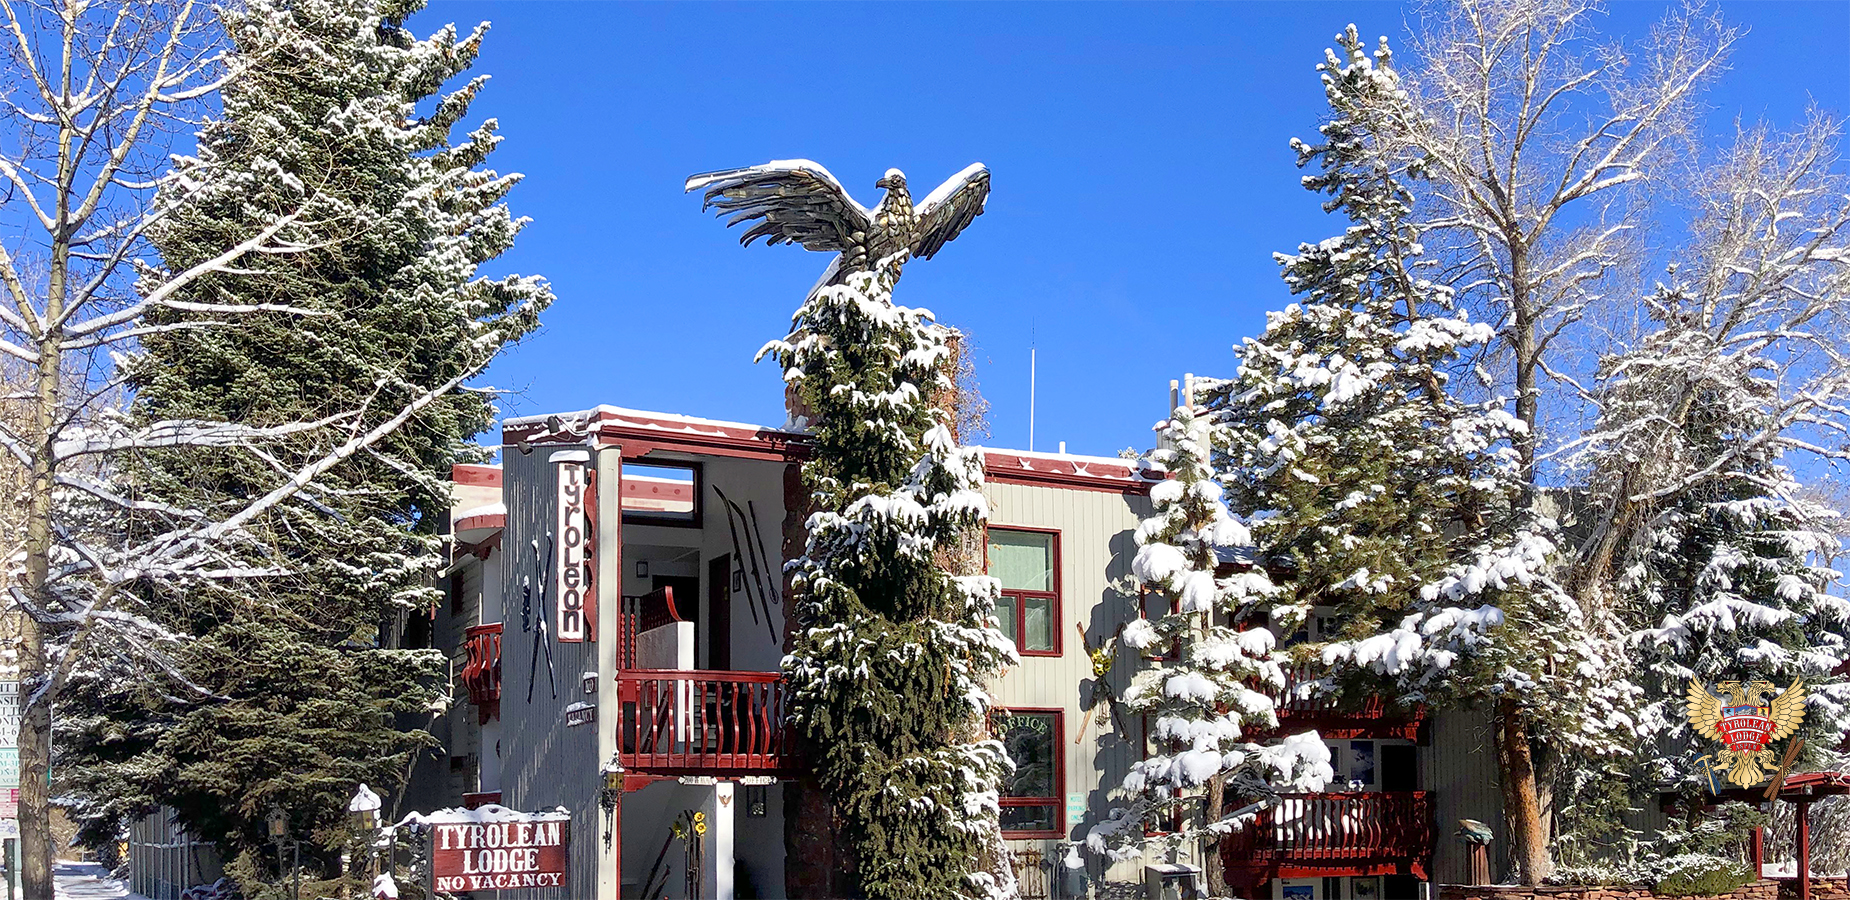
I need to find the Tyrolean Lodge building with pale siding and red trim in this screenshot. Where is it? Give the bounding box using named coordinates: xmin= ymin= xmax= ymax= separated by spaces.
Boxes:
xmin=405 ymin=406 xmax=1539 ymax=900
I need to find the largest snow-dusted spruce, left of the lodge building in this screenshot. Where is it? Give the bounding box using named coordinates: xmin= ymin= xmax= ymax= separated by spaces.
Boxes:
xmin=59 ymin=0 xmax=549 ymax=874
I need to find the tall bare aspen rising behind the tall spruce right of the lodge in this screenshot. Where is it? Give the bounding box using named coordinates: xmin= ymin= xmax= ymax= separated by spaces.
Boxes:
xmin=1393 ymin=0 xmax=1737 ymax=883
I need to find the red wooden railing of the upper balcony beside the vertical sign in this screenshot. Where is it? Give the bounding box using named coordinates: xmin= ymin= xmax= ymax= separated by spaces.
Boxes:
xmin=616 ymin=669 xmax=788 ymax=774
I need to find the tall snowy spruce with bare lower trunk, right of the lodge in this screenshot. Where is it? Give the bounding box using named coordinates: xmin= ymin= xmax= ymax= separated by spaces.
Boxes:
xmin=1208 ymin=26 xmax=1624 ymax=878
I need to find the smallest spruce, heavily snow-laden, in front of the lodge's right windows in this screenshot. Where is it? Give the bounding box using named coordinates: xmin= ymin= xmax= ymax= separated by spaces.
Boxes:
xmin=1067 ymin=406 xmax=1330 ymax=880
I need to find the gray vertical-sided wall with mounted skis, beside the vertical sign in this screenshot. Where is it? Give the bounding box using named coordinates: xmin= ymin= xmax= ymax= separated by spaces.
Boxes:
xmin=501 ymin=446 xmax=609 ymax=898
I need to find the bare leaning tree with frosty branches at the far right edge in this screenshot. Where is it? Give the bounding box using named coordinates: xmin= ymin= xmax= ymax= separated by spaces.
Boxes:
xmin=1569 ymin=117 xmax=1850 ymax=591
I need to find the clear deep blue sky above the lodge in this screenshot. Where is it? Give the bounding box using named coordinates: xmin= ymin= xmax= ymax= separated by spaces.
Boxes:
xmin=440 ymin=0 xmax=1850 ymax=456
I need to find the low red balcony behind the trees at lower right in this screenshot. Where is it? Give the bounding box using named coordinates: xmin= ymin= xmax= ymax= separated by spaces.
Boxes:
xmin=1221 ymin=791 xmax=1436 ymax=896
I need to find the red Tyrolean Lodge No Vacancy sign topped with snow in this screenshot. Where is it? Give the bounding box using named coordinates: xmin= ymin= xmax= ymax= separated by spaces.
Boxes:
xmin=431 ymin=813 xmax=572 ymax=893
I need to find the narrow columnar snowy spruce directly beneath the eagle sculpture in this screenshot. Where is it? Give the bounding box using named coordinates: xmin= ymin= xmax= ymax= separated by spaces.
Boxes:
xmin=760 ymin=263 xmax=1016 ymax=900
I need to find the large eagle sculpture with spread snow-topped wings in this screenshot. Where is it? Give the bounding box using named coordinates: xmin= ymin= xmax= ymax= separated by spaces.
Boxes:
xmin=686 ymin=159 xmax=990 ymax=289
